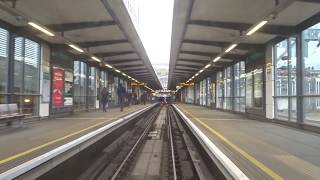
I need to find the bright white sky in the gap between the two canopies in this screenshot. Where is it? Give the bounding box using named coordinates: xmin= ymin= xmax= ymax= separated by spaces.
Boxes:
xmin=123 ymin=0 xmax=173 ymax=89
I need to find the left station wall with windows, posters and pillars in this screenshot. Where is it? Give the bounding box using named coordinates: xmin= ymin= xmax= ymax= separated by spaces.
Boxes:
xmin=0 ymin=23 xmax=144 ymax=119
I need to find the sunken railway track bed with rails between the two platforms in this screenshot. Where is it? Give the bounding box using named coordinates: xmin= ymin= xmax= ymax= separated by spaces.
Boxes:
xmin=3 ymin=105 xmax=237 ymax=180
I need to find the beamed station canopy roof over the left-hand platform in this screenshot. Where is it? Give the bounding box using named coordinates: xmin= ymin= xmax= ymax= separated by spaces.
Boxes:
xmin=0 ymin=0 xmax=161 ymax=89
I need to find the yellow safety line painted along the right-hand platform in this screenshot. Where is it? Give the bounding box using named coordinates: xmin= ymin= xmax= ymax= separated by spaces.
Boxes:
xmin=179 ymin=106 xmax=284 ymax=180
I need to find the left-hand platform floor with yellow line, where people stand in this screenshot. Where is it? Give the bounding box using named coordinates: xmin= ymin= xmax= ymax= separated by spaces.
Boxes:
xmin=0 ymin=104 xmax=150 ymax=173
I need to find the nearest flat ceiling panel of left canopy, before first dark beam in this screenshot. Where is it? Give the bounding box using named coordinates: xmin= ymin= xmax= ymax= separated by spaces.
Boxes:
xmin=17 ymin=0 xmax=112 ymax=24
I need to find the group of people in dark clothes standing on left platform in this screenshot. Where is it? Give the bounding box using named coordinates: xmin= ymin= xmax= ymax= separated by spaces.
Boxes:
xmin=100 ymin=84 xmax=147 ymax=112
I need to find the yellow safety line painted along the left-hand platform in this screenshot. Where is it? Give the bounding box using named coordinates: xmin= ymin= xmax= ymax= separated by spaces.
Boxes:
xmin=0 ymin=107 xmax=140 ymax=165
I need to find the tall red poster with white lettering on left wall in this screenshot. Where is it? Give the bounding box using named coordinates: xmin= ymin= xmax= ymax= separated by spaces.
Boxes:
xmin=52 ymin=68 xmax=64 ymax=107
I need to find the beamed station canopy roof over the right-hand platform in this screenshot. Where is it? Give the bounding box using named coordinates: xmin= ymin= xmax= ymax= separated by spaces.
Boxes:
xmin=168 ymin=0 xmax=320 ymax=89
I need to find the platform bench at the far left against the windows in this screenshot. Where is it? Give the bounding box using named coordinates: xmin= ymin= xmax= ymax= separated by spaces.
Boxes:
xmin=0 ymin=104 xmax=25 ymax=125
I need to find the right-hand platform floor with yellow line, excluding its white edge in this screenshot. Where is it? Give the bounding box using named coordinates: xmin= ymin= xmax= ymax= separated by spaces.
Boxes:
xmin=177 ymin=104 xmax=320 ymax=180
